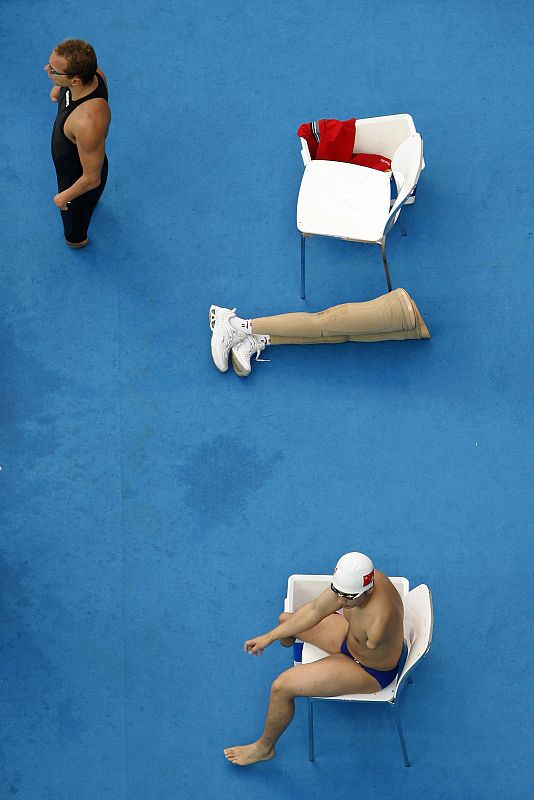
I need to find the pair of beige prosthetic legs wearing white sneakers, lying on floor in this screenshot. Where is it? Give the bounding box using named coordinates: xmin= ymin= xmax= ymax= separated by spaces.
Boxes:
xmin=209 ymin=289 xmax=430 ymax=377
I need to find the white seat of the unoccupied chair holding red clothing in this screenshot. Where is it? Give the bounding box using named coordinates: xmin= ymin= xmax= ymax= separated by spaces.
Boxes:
xmin=297 ymin=161 xmax=391 ymax=243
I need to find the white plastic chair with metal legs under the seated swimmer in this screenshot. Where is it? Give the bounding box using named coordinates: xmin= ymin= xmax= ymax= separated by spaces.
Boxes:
xmin=284 ymin=575 xmax=434 ymax=767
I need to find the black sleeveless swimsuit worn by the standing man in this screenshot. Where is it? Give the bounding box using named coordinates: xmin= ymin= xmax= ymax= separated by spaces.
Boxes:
xmin=52 ymin=72 xmax=108 ymax=244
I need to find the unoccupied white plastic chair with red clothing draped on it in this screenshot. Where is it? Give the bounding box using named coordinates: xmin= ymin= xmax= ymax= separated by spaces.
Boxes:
xmin=297 ymin=114 xmax=424 ymax=299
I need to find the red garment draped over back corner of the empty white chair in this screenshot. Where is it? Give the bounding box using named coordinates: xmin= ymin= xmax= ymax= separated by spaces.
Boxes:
xmin=297 ymin=117 xmax=391 ymax=172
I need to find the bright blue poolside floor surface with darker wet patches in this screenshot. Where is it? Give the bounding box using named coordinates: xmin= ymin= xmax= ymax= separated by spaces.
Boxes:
xmin=0 ymin=0 xmax=534 ymax=800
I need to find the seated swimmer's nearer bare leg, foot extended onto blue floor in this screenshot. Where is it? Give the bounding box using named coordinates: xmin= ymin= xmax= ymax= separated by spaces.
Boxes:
xmin=224 ymin=653 xmax=380 ymax=767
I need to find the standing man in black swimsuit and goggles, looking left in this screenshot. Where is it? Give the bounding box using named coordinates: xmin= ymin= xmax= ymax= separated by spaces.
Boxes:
xmin=44 ymin=39 xmax=111 ymax=248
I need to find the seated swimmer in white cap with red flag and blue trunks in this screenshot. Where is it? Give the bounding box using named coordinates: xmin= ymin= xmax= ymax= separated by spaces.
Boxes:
xmin=224 ymin=553 xmax=406 ymax=766
